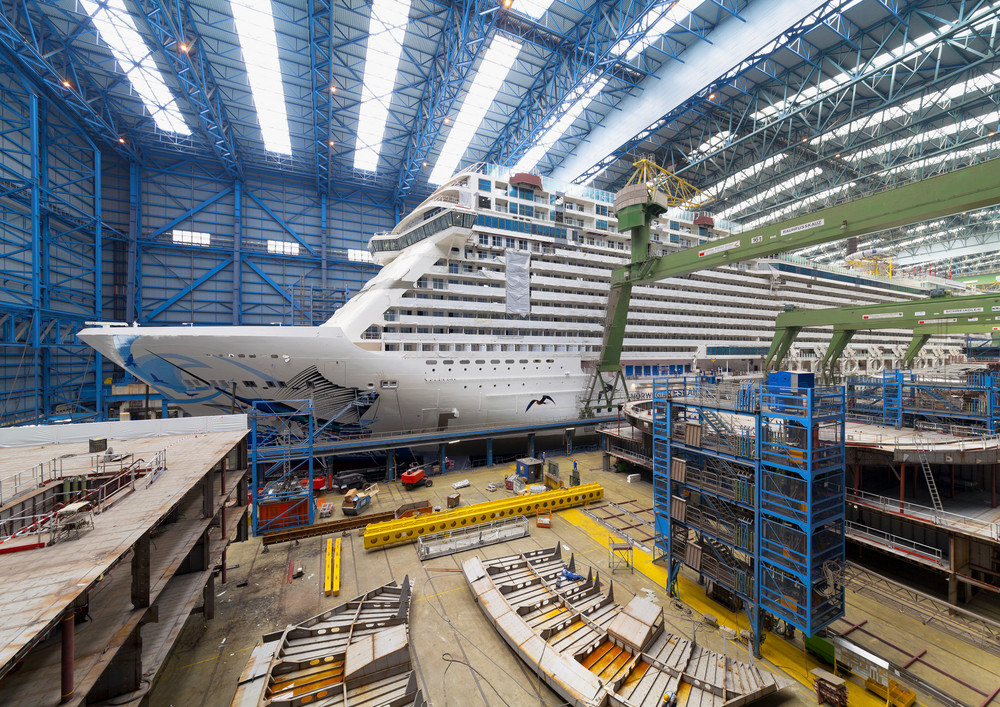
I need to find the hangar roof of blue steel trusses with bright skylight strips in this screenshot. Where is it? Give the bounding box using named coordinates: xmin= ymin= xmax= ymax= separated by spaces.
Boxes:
xmin=0 ymin=0 xmax=1000 ymax=276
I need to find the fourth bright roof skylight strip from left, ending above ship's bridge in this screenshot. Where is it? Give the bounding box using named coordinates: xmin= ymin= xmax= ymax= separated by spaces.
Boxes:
xmin=428 ymin=36 xmax=522 ymax=184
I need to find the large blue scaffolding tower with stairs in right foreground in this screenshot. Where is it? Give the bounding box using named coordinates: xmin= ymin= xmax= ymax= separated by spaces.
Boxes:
xmin=653 ymin=374 xmax=845 ymax=655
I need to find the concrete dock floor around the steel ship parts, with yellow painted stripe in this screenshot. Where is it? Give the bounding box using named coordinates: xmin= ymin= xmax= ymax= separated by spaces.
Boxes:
xmin=151 ymin=452 xmax=1000 ymax=707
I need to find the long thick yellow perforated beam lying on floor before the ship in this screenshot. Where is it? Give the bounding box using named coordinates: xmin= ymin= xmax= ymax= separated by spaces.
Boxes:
xmin=365 ymin=484 xmax=604 ymax=550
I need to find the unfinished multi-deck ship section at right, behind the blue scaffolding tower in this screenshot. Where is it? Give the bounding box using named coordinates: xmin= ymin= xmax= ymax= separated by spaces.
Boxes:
xmin=598 ymin=390 xmax=1000 ymax=604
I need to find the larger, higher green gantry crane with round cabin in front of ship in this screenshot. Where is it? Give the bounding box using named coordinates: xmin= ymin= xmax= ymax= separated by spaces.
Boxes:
xmin=587 ymin=159 xmax=1000 ymax=411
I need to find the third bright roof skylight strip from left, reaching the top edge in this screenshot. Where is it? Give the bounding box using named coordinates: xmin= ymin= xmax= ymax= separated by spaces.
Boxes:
xmin=354 ymin=0 xmax=410 ymax=172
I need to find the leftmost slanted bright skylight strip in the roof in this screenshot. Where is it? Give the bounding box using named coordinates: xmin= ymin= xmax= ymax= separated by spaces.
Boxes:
xmin=80 ymin=0 xmax=191 ymax=135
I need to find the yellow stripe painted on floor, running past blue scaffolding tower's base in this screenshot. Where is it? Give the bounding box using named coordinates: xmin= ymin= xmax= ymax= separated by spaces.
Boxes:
xmin=559 ymin=508 xmax=885 ymax=707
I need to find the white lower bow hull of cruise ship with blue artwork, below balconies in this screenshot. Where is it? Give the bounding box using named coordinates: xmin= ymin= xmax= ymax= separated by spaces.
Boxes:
xmin=80 ymin=326 xmax=589 ymax=431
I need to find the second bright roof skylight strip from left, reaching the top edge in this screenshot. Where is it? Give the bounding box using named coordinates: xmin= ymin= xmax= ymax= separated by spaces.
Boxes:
xmin=229 ymin=0 xmax=292 ymax=155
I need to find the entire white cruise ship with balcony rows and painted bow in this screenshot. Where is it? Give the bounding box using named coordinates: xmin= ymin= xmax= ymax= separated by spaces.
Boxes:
xmin=80 ymin=165 xmax=960 ymax=430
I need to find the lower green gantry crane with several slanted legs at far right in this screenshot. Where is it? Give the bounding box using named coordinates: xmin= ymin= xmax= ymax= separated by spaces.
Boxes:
xmin=764 ymin=294 xmax=1000 ymax=372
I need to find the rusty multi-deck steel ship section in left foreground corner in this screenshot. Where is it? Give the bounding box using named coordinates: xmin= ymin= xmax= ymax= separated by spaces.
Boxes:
xmin=0 ymin=415 xmax=247 ymax=706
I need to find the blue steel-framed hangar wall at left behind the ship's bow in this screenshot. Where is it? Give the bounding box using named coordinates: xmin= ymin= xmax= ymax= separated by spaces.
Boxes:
xmin=0 ymin=72 xmax=396 ymax=424
